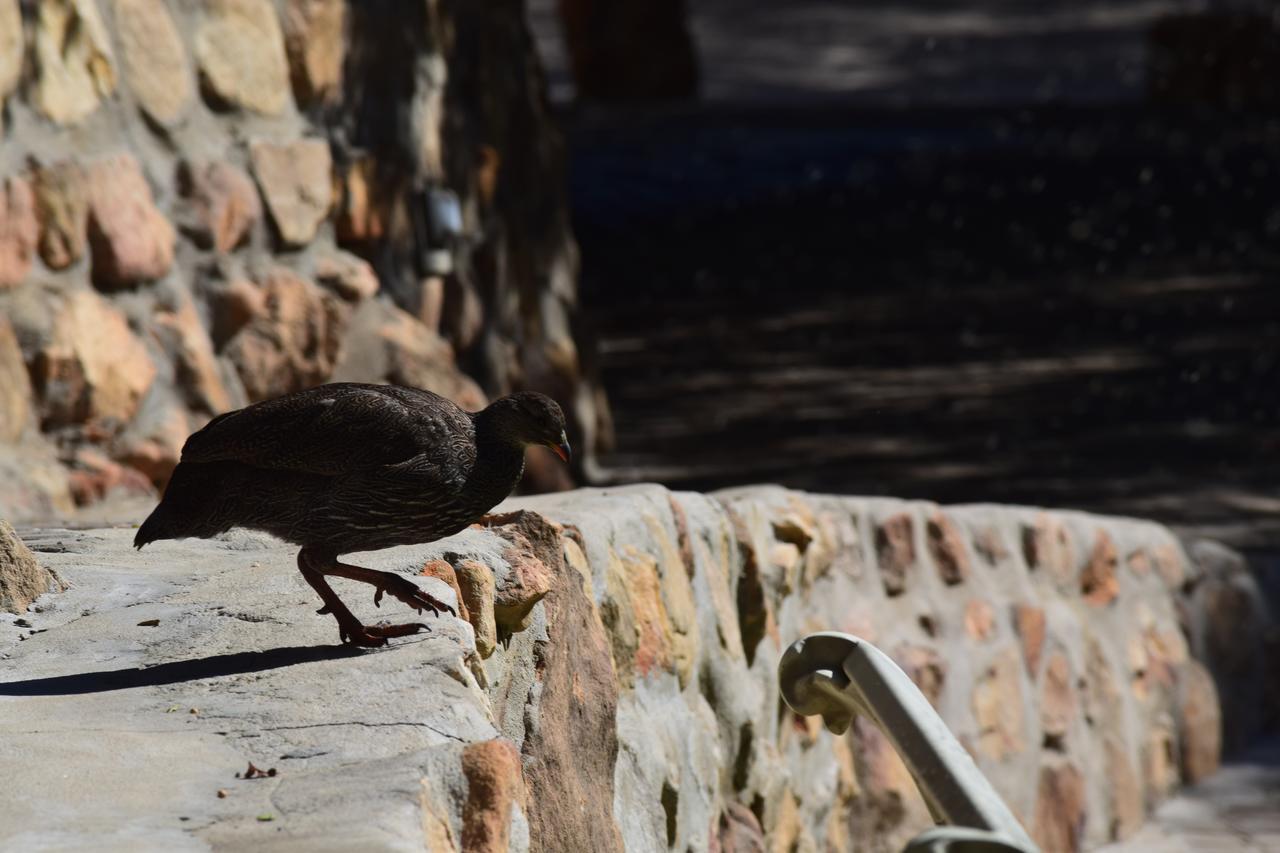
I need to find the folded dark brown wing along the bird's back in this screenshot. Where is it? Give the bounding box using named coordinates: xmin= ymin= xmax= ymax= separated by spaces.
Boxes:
xmin=182 ymin=383 xmax=475 ymax=479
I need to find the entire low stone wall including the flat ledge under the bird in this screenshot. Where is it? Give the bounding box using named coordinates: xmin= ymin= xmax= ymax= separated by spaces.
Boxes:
xmin=0 ymin=487 xmax=1276 ymax=853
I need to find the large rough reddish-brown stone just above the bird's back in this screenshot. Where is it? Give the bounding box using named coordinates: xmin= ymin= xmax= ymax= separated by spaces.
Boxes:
xmin=224 ymin=266 xmax=346 ymax=401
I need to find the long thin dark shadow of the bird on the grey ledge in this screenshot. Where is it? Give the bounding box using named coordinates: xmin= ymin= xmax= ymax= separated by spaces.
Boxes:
xmin=0 ymin=646 xmax=366 ymax=695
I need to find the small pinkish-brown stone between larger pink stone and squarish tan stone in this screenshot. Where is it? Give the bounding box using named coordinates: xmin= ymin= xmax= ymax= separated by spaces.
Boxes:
xmin=178 ymin=160 xmax=262 ymax=252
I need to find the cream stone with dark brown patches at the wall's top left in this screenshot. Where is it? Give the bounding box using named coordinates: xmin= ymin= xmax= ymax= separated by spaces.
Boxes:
xmin=31 ymin=0 xmax=115 ymax=124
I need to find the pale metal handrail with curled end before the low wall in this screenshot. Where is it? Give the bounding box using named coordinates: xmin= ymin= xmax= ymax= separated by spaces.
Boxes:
xmin=778 ymin=631 xmax=1039 ymax=853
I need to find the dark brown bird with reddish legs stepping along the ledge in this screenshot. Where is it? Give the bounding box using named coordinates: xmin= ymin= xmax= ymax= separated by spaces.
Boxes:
xmin=133 ymin=382 xmax=571 ymax=647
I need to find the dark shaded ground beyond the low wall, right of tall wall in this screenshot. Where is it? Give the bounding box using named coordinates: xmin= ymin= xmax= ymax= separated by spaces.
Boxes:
xmin=531 ymin=0 xmax=1280 ymax=548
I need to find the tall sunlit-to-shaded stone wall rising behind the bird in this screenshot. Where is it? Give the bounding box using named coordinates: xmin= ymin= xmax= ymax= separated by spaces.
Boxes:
xmin=0 ymin=0 xmax=603 ymax=519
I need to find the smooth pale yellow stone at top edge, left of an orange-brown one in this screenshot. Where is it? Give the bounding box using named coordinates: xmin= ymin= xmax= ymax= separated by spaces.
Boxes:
xmin=196 ymin=0 xmax=289 ymax=115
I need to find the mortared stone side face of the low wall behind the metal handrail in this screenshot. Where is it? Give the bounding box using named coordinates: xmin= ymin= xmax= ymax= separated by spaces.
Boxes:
xmin=488 ymin=487 xmax=1274 ymax=850
